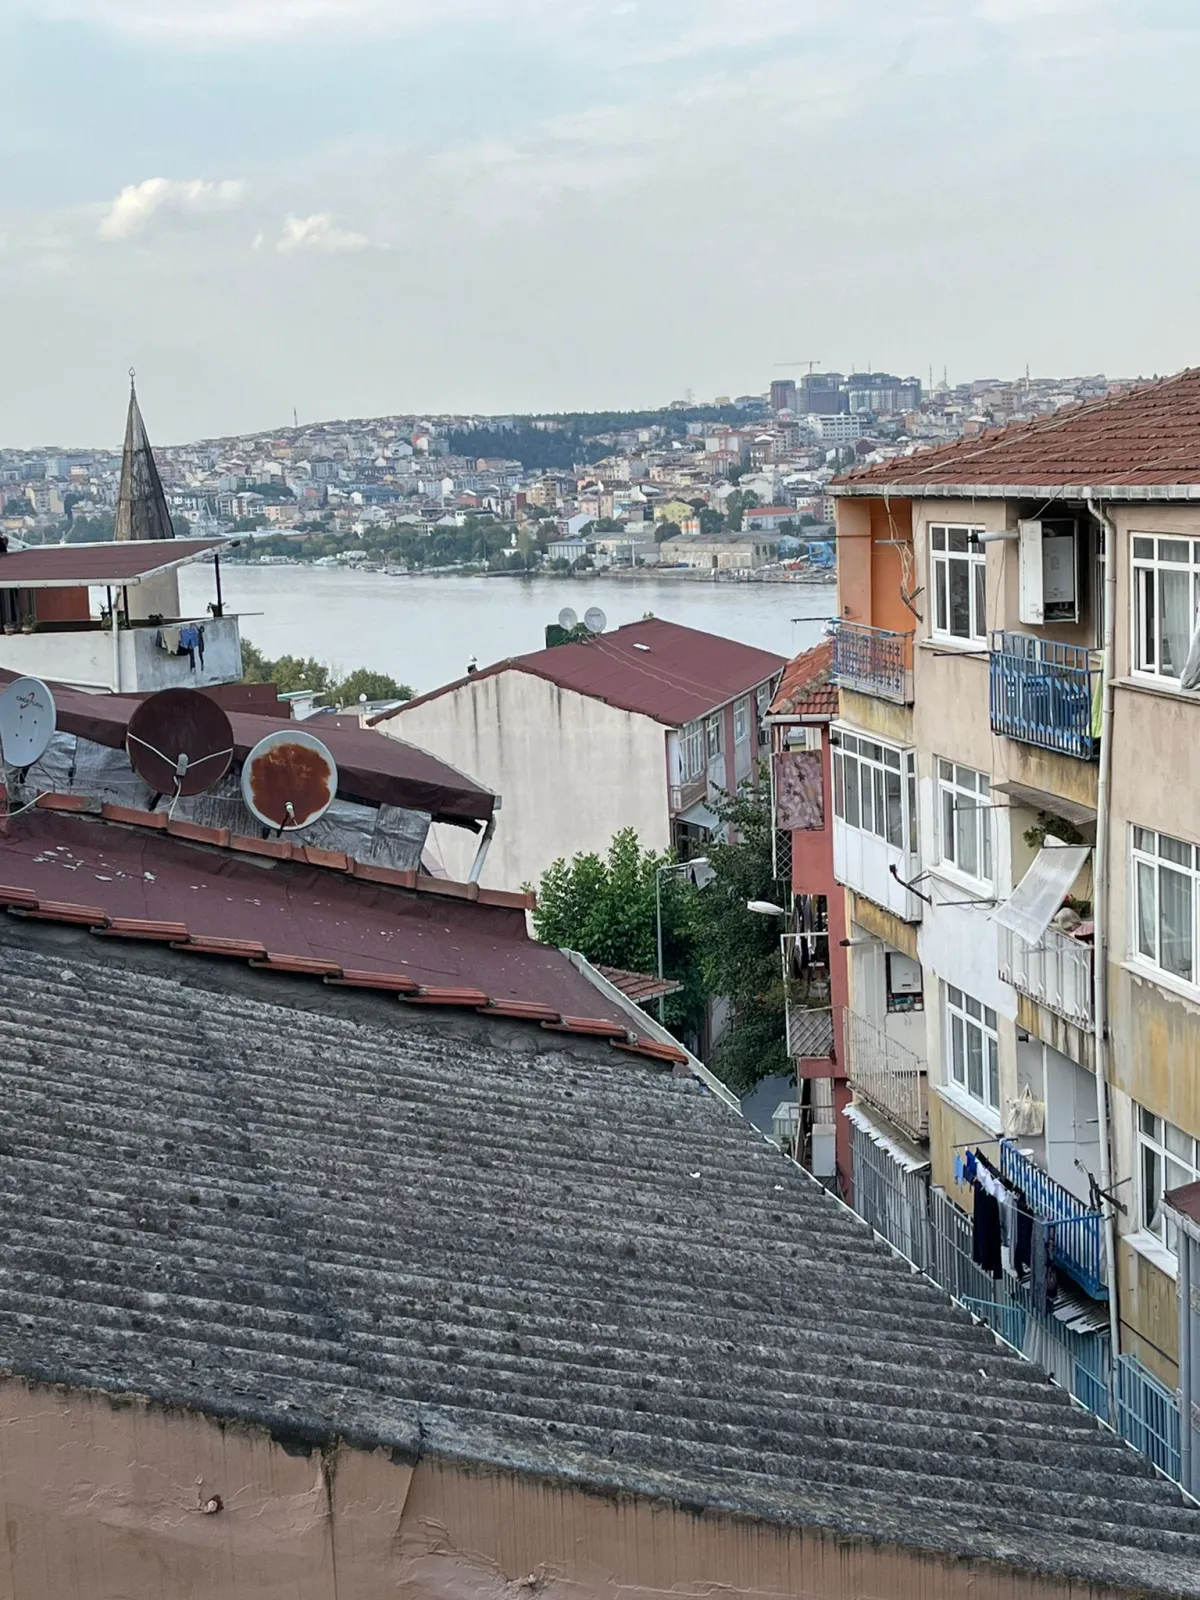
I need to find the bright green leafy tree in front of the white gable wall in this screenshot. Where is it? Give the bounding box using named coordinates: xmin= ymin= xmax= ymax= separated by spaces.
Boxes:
xmin=533 ymin=827 xmax=706 ymax=1035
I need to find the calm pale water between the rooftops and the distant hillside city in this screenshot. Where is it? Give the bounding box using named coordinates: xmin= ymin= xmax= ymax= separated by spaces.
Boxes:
xmin=179 ymin=565 xmax=834 ymax=693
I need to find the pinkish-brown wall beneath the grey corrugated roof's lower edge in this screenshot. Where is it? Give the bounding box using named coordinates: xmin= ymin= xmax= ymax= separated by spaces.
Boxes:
xmin=0 ymin=1379 xmax=1164 ymax=1600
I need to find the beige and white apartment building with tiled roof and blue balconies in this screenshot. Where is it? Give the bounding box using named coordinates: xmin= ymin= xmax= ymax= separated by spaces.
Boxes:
xmin=830 ymin=371 xmax=1200 ymax=1486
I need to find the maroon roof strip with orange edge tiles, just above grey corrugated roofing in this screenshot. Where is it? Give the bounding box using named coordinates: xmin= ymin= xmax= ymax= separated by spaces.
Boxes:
xmin=0 ymin=812 xmax=686 ymax=1062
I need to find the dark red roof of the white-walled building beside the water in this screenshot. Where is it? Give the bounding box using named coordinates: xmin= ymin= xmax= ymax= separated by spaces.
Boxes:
xmin=371 ymin=618 xmax=786 ymax=728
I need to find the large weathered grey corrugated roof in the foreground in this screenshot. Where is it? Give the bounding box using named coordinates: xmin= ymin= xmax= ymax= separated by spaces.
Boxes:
xmin=0 ymin=925 xmax=1200 ymax=1595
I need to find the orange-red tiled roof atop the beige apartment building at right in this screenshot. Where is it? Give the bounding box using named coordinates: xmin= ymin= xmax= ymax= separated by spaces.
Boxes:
xmin=832 ymin=368 xmax=1200 ymax=498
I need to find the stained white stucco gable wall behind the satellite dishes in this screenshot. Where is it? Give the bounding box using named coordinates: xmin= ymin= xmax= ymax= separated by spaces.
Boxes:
xmin=379 ymin=669 xmax=670 ymax=890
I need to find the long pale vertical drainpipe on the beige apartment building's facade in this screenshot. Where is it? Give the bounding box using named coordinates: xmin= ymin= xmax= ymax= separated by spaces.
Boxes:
xmin=1086 ymin=494 xmax=1122 ymax=1408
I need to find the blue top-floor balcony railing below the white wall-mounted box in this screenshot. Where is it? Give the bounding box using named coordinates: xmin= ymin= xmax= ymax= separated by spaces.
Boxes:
xmin=992 ymin=632 xmax=1099 ymax=762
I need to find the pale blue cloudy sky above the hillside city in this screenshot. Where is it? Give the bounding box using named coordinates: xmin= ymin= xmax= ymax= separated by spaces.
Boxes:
xmin=0 ymin=0 xmax=1200 ymax=445
